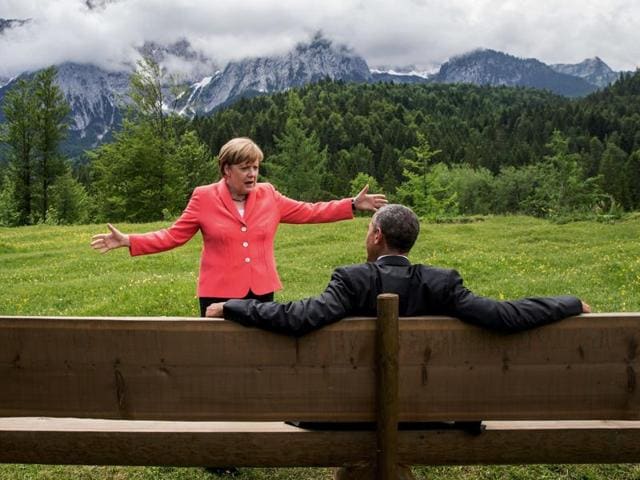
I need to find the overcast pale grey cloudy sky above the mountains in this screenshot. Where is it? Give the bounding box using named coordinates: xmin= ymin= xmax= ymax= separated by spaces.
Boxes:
xmin=0 ymin=0 xmax=640 ymax=76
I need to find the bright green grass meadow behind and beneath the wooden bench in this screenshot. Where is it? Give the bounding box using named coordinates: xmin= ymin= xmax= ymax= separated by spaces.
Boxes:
xmin=0 ymin=216 xmax=640 ymax=480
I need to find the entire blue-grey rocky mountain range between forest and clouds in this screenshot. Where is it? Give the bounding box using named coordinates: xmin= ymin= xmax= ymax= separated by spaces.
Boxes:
xmin=0 ymin=19 xmax=632 ymax=155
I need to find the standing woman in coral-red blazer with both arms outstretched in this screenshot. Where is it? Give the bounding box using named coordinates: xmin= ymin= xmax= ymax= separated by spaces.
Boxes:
xmin=91 ymin=138 xmax=387 ymax=317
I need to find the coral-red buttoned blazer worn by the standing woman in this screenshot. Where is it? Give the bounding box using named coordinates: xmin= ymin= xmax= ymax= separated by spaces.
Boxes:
xmin=129 ymin=180 xmax=353 ymax=298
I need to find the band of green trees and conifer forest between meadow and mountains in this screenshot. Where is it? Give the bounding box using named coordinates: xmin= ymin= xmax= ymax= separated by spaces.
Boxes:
xmin=0 ymin=60 xmax=640 ymax=225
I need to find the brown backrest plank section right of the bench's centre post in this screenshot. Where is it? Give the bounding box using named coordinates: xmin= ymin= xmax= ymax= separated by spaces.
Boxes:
xmin=400 ymin=314 xmax=640 ymax=420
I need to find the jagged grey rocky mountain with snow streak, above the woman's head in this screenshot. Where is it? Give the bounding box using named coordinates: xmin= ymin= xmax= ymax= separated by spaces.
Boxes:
xmin=178 ymin=34 xmax=372 ymax=115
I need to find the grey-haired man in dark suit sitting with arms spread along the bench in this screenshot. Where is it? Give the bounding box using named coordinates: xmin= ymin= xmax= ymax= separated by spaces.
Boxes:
xmin=206 ymin=204 xmax=591 ymax=479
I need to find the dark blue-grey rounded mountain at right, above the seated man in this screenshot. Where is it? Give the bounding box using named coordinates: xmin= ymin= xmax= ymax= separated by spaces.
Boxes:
xmin=432 ymin=49 xmax=598 ymax=97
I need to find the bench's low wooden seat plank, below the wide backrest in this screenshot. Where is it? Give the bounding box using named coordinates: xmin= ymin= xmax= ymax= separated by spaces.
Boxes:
xmin=0 ymin=418 xmax=640 ymax=467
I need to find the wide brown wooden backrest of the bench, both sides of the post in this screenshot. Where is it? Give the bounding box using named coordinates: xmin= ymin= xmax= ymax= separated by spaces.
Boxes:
xmin=0 ymin=314 xmax=640 ymax=421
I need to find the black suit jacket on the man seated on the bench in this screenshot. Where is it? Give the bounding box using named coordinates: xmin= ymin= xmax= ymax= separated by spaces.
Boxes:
xmin=224 ymin=255 xmax=582 ymax=336
